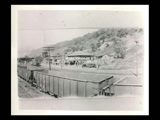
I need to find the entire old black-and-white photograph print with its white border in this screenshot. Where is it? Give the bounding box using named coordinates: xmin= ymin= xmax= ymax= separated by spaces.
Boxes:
xmin=11 ymin=5 xmax=148 ymax=115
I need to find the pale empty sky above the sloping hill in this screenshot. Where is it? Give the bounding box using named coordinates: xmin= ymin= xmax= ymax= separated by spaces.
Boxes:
xmin=18 ymin=10 xmax=144 ymax=54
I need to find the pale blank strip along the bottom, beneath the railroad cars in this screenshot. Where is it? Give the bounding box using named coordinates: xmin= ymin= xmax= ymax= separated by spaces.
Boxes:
xmin=19 ymin=97 xmax=143 ymax=111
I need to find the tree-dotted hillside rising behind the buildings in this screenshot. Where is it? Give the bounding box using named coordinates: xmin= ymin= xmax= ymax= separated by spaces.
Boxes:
xmin=26 ymin=28 xmax=143 ymax=69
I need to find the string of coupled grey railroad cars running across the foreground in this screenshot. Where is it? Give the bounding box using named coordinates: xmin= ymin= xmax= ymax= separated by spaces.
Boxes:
xmin=17 ymin=67 xmax=143 ymax=97
